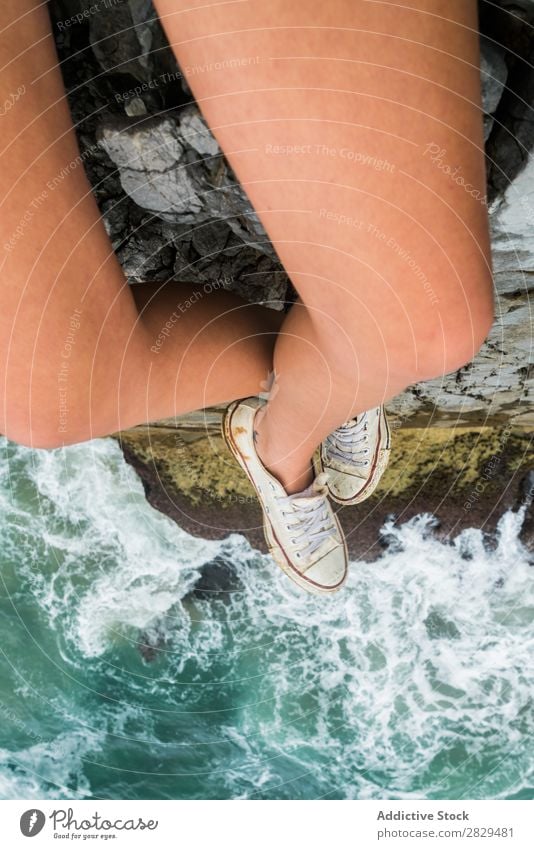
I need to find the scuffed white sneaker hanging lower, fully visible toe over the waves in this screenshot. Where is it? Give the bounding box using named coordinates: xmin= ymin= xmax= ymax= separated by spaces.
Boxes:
xmin=223 ymin=398 xmax=347 ymax=594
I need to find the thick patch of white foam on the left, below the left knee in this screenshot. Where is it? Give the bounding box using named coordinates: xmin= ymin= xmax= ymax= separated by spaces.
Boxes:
xmin=3 ymin=439 xmax=224 ymax=657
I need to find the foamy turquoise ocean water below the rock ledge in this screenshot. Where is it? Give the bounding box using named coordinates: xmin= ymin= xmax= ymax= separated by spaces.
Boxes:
xmin=0 ymin=439 xmax=534 ymax=799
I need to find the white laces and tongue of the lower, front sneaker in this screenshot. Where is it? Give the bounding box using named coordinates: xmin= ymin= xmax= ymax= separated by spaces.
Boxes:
xmin=276 ymin=473 xmax=336 ymax=557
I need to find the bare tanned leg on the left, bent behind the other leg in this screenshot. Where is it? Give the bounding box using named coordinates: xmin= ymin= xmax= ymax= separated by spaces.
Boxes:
xmin=0 ymin=0 xmax=281 ymax=447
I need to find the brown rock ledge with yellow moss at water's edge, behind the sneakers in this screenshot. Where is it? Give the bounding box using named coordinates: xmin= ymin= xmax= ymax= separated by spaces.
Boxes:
xmin=118 ymin=424 xmax=534 ymax=564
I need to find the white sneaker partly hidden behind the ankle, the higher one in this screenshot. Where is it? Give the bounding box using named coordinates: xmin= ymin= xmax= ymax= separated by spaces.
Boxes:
xmin=313 ymin=407 xmax=391 ymax=504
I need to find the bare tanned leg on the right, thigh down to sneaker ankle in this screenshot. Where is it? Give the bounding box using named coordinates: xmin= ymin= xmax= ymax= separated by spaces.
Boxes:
xmin=156 ymin=0 xmax=493 ymax=492
